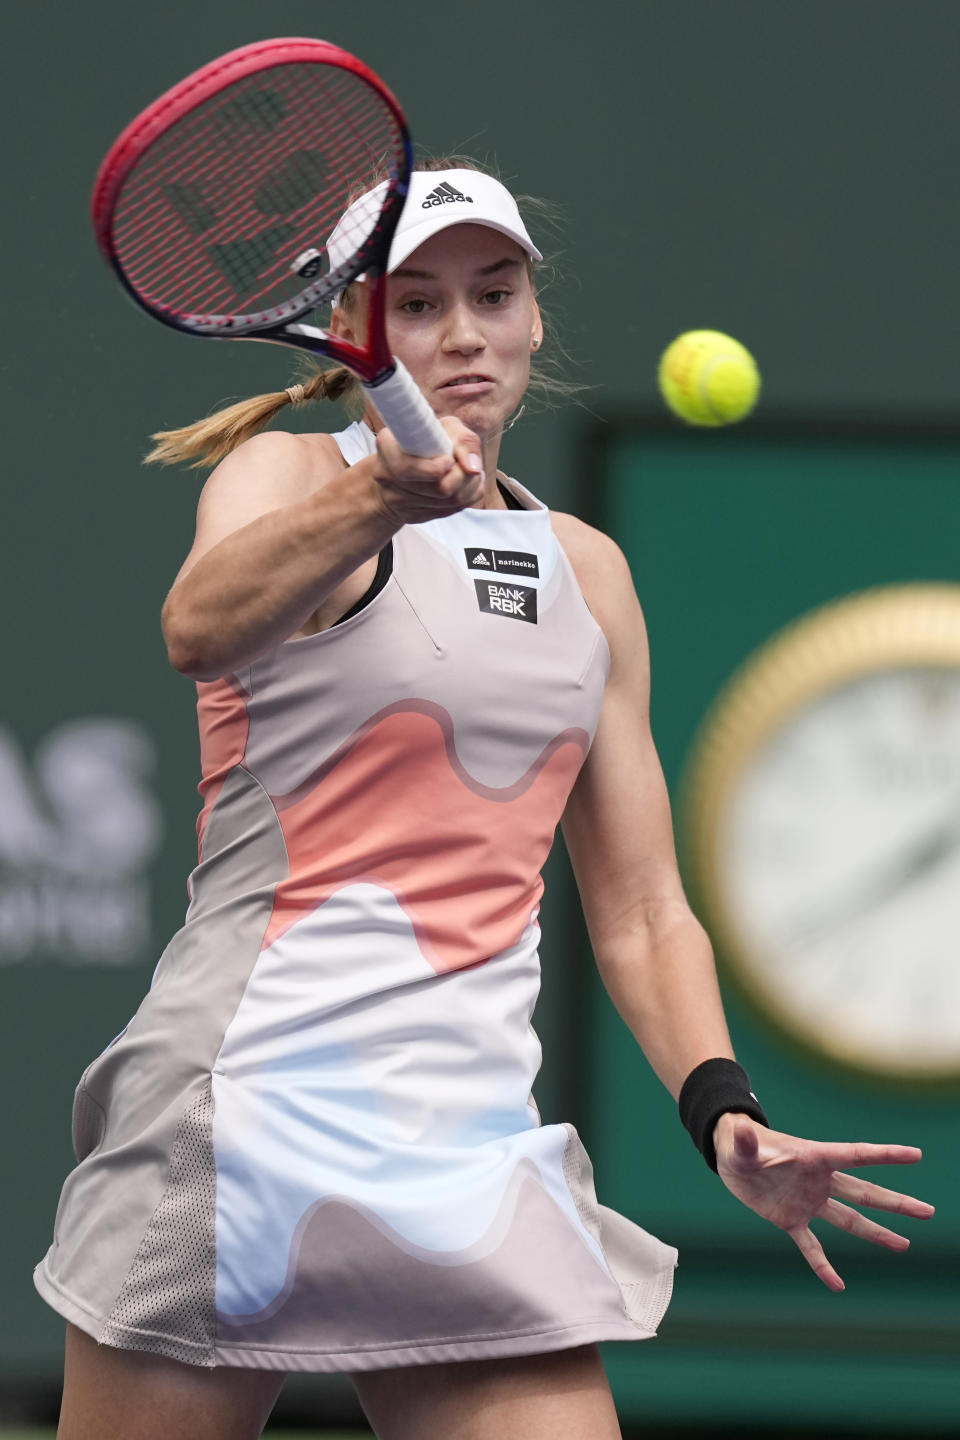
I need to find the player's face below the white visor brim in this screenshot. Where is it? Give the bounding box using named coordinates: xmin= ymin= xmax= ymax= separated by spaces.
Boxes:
xmin=387 ymin=225 xmax=543 ymax=439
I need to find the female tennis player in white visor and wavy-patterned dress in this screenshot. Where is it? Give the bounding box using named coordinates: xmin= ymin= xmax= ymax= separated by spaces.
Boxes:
xmin=37 ymin=161 xmax=933 ymax=1440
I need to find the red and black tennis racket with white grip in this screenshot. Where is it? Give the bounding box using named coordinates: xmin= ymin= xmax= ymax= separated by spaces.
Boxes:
xmin=92 ymin=39 xmax=452 ymax=455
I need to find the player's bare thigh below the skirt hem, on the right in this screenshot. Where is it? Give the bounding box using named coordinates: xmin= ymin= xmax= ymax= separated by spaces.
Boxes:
xmin=350 ymin=1345 xmax=620 ymax=1440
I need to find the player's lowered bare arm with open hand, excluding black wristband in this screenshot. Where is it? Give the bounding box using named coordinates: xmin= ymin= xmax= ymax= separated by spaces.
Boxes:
xmin=560 ymin=520 xmax=933 ymax=1290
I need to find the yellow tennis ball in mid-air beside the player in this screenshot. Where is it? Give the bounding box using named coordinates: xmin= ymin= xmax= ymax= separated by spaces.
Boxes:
xmin=658 ymin=330 xmax=760 ymax=425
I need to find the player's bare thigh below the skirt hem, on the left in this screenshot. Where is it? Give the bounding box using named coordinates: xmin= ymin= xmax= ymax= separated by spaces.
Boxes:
xmin=56 ymin=1325 xmax=284 ymax=1440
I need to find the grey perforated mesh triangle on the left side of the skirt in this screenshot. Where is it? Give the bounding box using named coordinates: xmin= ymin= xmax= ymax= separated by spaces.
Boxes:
xmin=98 ymin=1081 xmax=216 ymax=1365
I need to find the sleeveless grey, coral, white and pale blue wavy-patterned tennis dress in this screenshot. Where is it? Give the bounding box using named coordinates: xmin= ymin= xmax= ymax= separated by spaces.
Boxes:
xmin=36 ymin=425 xmax=676 ymax=1371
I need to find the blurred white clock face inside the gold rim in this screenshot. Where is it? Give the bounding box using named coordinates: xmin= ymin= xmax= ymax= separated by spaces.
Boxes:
xmin=725 ymin=665 xmax=960 ymax=1076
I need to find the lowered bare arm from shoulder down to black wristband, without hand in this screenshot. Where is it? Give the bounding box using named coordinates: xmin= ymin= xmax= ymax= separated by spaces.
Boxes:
xmin=563 ymin=527 xmax=733 ymax=1099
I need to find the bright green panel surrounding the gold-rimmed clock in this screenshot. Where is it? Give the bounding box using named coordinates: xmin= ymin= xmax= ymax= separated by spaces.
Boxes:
xmin=583 ymin=416 xmax=960 ymax=1434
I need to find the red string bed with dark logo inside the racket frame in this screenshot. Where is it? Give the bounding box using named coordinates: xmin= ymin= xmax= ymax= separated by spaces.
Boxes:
xmin=114 ymin=63 xmax=404 ymax=315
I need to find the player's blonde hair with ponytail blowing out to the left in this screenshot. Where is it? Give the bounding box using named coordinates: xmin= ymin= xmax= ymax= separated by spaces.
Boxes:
xmin=145 ymin=156 xmax=584 ymax=469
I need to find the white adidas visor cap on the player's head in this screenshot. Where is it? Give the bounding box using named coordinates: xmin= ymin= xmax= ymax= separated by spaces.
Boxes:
xmin=327 ymin=170 xmax=543 ymax=283
